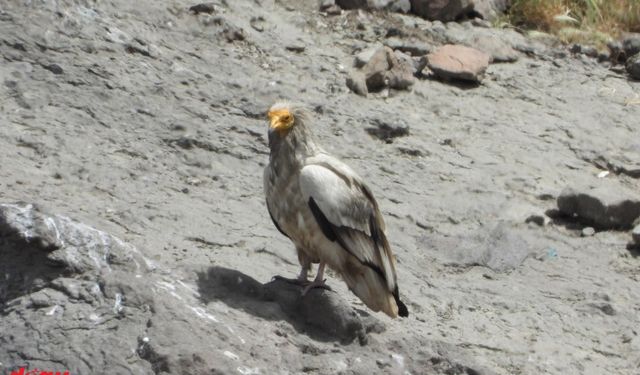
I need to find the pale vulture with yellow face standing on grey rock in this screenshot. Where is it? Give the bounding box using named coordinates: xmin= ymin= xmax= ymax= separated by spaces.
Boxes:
xmin=264 ymin=102 xmax=409 ymax=318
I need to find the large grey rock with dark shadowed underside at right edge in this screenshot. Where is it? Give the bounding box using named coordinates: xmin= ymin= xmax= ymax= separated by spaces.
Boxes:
xmin=558 ymin=186 xmax=640 ymax=229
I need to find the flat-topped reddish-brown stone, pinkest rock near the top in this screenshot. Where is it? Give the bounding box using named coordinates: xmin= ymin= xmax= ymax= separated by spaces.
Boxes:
xmin=427 ymin=44 xmax=490 ymax=82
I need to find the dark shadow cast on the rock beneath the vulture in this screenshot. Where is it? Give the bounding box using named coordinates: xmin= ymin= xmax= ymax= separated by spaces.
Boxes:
xmin=197 ymin=267 xmax=385 ymax=345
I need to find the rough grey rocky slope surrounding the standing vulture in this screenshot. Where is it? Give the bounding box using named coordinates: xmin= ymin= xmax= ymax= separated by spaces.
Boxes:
xmin=0 ymin=0 xmax=640 ymax=375
